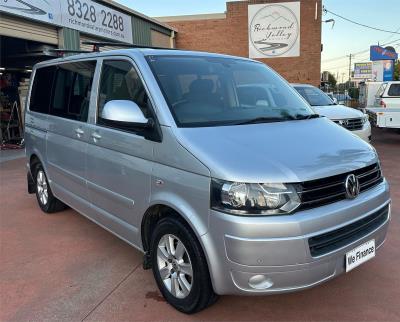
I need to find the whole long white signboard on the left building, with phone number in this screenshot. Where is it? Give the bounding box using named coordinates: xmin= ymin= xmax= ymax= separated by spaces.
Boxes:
xmin=0 ymin=0 xmax=133 ymax=43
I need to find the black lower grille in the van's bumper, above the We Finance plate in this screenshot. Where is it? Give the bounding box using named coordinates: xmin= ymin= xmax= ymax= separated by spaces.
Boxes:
xmin=308 ymin=206 xmax=389 ymax=257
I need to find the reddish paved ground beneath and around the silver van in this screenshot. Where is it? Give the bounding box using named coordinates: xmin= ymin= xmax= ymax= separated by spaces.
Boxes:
xmin=0 ymin=130 xmax=400 ymax=321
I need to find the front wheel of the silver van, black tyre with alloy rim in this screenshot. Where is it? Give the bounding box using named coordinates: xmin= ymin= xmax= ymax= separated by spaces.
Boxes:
xmin=150 ymin=217 xmax=217 ymax=314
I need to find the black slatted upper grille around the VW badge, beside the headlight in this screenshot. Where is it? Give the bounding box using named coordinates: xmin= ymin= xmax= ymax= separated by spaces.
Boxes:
xmin=299 ymin=163 xmax=383 ymax=210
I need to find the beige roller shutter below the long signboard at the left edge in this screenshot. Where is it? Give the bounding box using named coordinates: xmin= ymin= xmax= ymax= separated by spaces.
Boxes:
xmin=0 ymin=13 xmax=58 ymax=45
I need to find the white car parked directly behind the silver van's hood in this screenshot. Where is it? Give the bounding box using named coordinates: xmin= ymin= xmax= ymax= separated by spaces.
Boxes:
xmin=292 ymin=84 xmax=371 ymax=142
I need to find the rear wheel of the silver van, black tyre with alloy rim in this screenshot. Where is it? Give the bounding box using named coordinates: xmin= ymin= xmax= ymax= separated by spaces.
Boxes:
xmin=32 ymin=163 xmax=67 ymax=214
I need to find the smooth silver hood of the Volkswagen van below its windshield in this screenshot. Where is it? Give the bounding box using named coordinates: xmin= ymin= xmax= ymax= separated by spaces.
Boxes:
xmin=175 ymin=117 xmax=377 ymax=183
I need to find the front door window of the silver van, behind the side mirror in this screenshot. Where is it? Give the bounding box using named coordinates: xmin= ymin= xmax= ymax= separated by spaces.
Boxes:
xmin=97 ymin=60 xmax=151 ymax=125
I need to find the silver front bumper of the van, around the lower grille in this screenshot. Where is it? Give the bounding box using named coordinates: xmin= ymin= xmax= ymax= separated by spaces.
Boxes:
xmin=202 ymin=180 xmax=390 ymax=295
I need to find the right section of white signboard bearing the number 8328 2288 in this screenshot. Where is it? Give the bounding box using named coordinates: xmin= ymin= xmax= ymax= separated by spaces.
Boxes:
xmin=61 ymin=0 xmax=132 ymax=43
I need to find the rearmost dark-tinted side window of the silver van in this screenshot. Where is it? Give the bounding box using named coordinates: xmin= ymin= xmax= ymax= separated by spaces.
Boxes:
xmin=29 ymin=66 xmax=56 ymax=114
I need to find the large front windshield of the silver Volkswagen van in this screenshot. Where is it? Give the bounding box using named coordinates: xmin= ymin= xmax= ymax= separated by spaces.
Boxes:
xmin=147 ymin=56 xmax=314 ymax=127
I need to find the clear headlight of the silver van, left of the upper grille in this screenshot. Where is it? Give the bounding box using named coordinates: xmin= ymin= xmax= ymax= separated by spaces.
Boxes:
xmin=211 ymin=179 xmax=300 ymax=215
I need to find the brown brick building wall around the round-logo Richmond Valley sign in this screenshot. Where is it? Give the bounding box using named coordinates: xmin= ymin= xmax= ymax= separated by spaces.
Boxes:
xmin=156 ymin=0 xmax=322 ymax=85
